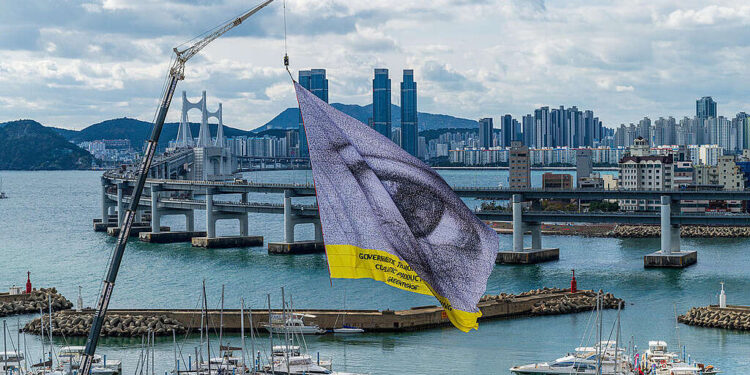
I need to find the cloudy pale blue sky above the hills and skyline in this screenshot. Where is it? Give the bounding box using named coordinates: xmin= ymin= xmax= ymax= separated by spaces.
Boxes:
xmin=0 ymin=0 xmax=750 ymax=130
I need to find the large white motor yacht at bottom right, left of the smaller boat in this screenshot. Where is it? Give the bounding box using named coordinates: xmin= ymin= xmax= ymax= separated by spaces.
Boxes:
xmin=510 ymin=341 xmax=634 ymax=375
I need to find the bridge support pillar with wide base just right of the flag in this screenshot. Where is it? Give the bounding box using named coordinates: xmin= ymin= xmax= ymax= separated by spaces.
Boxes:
xmin=495 ymin=194 xmax=560 ymax=264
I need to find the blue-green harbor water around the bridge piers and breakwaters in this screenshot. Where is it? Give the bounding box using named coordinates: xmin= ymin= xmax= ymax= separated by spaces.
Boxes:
xmin=0 ymin=170 xmax=750 ymax=374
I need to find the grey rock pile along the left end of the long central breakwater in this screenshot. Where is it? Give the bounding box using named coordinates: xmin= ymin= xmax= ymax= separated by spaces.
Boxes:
xmin=23 ymin=313 xmax=187 ymax=337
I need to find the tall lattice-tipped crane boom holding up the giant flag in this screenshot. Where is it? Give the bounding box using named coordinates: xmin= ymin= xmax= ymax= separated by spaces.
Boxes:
xmin=79 ymin=0 xmax=273 ymax=375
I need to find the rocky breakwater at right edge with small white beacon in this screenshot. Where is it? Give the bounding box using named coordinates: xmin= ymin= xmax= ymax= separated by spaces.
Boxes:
xmin=677 ymin=305 xmax=750 ymax=331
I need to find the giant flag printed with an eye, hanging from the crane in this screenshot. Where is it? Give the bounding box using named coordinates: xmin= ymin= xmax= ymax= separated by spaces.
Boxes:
xmin=294 ymin=82 xmax=499 ymax=332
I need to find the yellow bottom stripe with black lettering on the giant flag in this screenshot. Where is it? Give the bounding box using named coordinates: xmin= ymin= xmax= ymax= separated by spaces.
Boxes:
xmin=326 ymin=245 xmax=482 ymax=332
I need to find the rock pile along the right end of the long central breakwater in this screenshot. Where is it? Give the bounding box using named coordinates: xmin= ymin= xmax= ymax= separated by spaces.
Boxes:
xmin=480 ymin=287 xmax=625 ymax=315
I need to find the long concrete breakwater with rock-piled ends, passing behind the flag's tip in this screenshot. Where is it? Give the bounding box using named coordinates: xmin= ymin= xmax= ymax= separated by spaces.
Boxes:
xmin=24 ymin=288 xmax=622 ymax=337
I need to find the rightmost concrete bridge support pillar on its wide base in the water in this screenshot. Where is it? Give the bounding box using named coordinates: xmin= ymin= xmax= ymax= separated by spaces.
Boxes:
xmin=643 ymin=195 xmax=698 ymax=268
